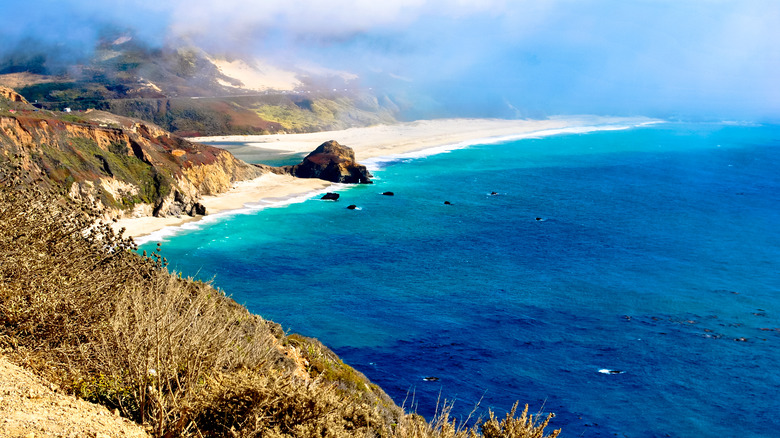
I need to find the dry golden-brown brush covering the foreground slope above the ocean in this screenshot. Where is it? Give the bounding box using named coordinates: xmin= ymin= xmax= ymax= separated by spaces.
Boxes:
xmin=0 ymin=168 xmax=558 ymax=438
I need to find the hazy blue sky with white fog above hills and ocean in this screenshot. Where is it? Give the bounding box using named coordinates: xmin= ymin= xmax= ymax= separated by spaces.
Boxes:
xmin=0 ymin=0 xmax=780 ymax=121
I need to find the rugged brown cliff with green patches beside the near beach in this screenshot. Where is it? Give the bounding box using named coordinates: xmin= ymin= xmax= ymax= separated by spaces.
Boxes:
xmin=0 ymin=87 xmax=262 ymax=217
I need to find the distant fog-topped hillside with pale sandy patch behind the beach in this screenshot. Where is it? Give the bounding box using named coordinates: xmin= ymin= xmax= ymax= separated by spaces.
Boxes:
xmin=0 ymin=34 xmax=399 ymax=136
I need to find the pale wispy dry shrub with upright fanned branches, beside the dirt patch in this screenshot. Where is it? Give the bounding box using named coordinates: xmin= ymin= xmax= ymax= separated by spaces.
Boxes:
xmin=89 ymin=273 xmax=280 ymax=435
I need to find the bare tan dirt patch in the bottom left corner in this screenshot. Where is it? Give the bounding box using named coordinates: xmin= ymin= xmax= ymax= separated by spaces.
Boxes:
xmin=0 ymin=357 xmax=149 ymax=438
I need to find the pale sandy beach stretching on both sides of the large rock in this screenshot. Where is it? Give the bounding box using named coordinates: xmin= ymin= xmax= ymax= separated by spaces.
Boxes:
xmin=119 ymin=116 xmax=660 ymax=243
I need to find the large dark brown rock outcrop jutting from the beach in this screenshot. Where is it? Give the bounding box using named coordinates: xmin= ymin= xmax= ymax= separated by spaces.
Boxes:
xmin=289 ymin=140 xmax=372 ymax=184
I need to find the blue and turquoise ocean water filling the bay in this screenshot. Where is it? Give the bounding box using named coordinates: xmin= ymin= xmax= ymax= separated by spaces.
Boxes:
xmin=142 ymin=123 xmax=780 ymax=437
